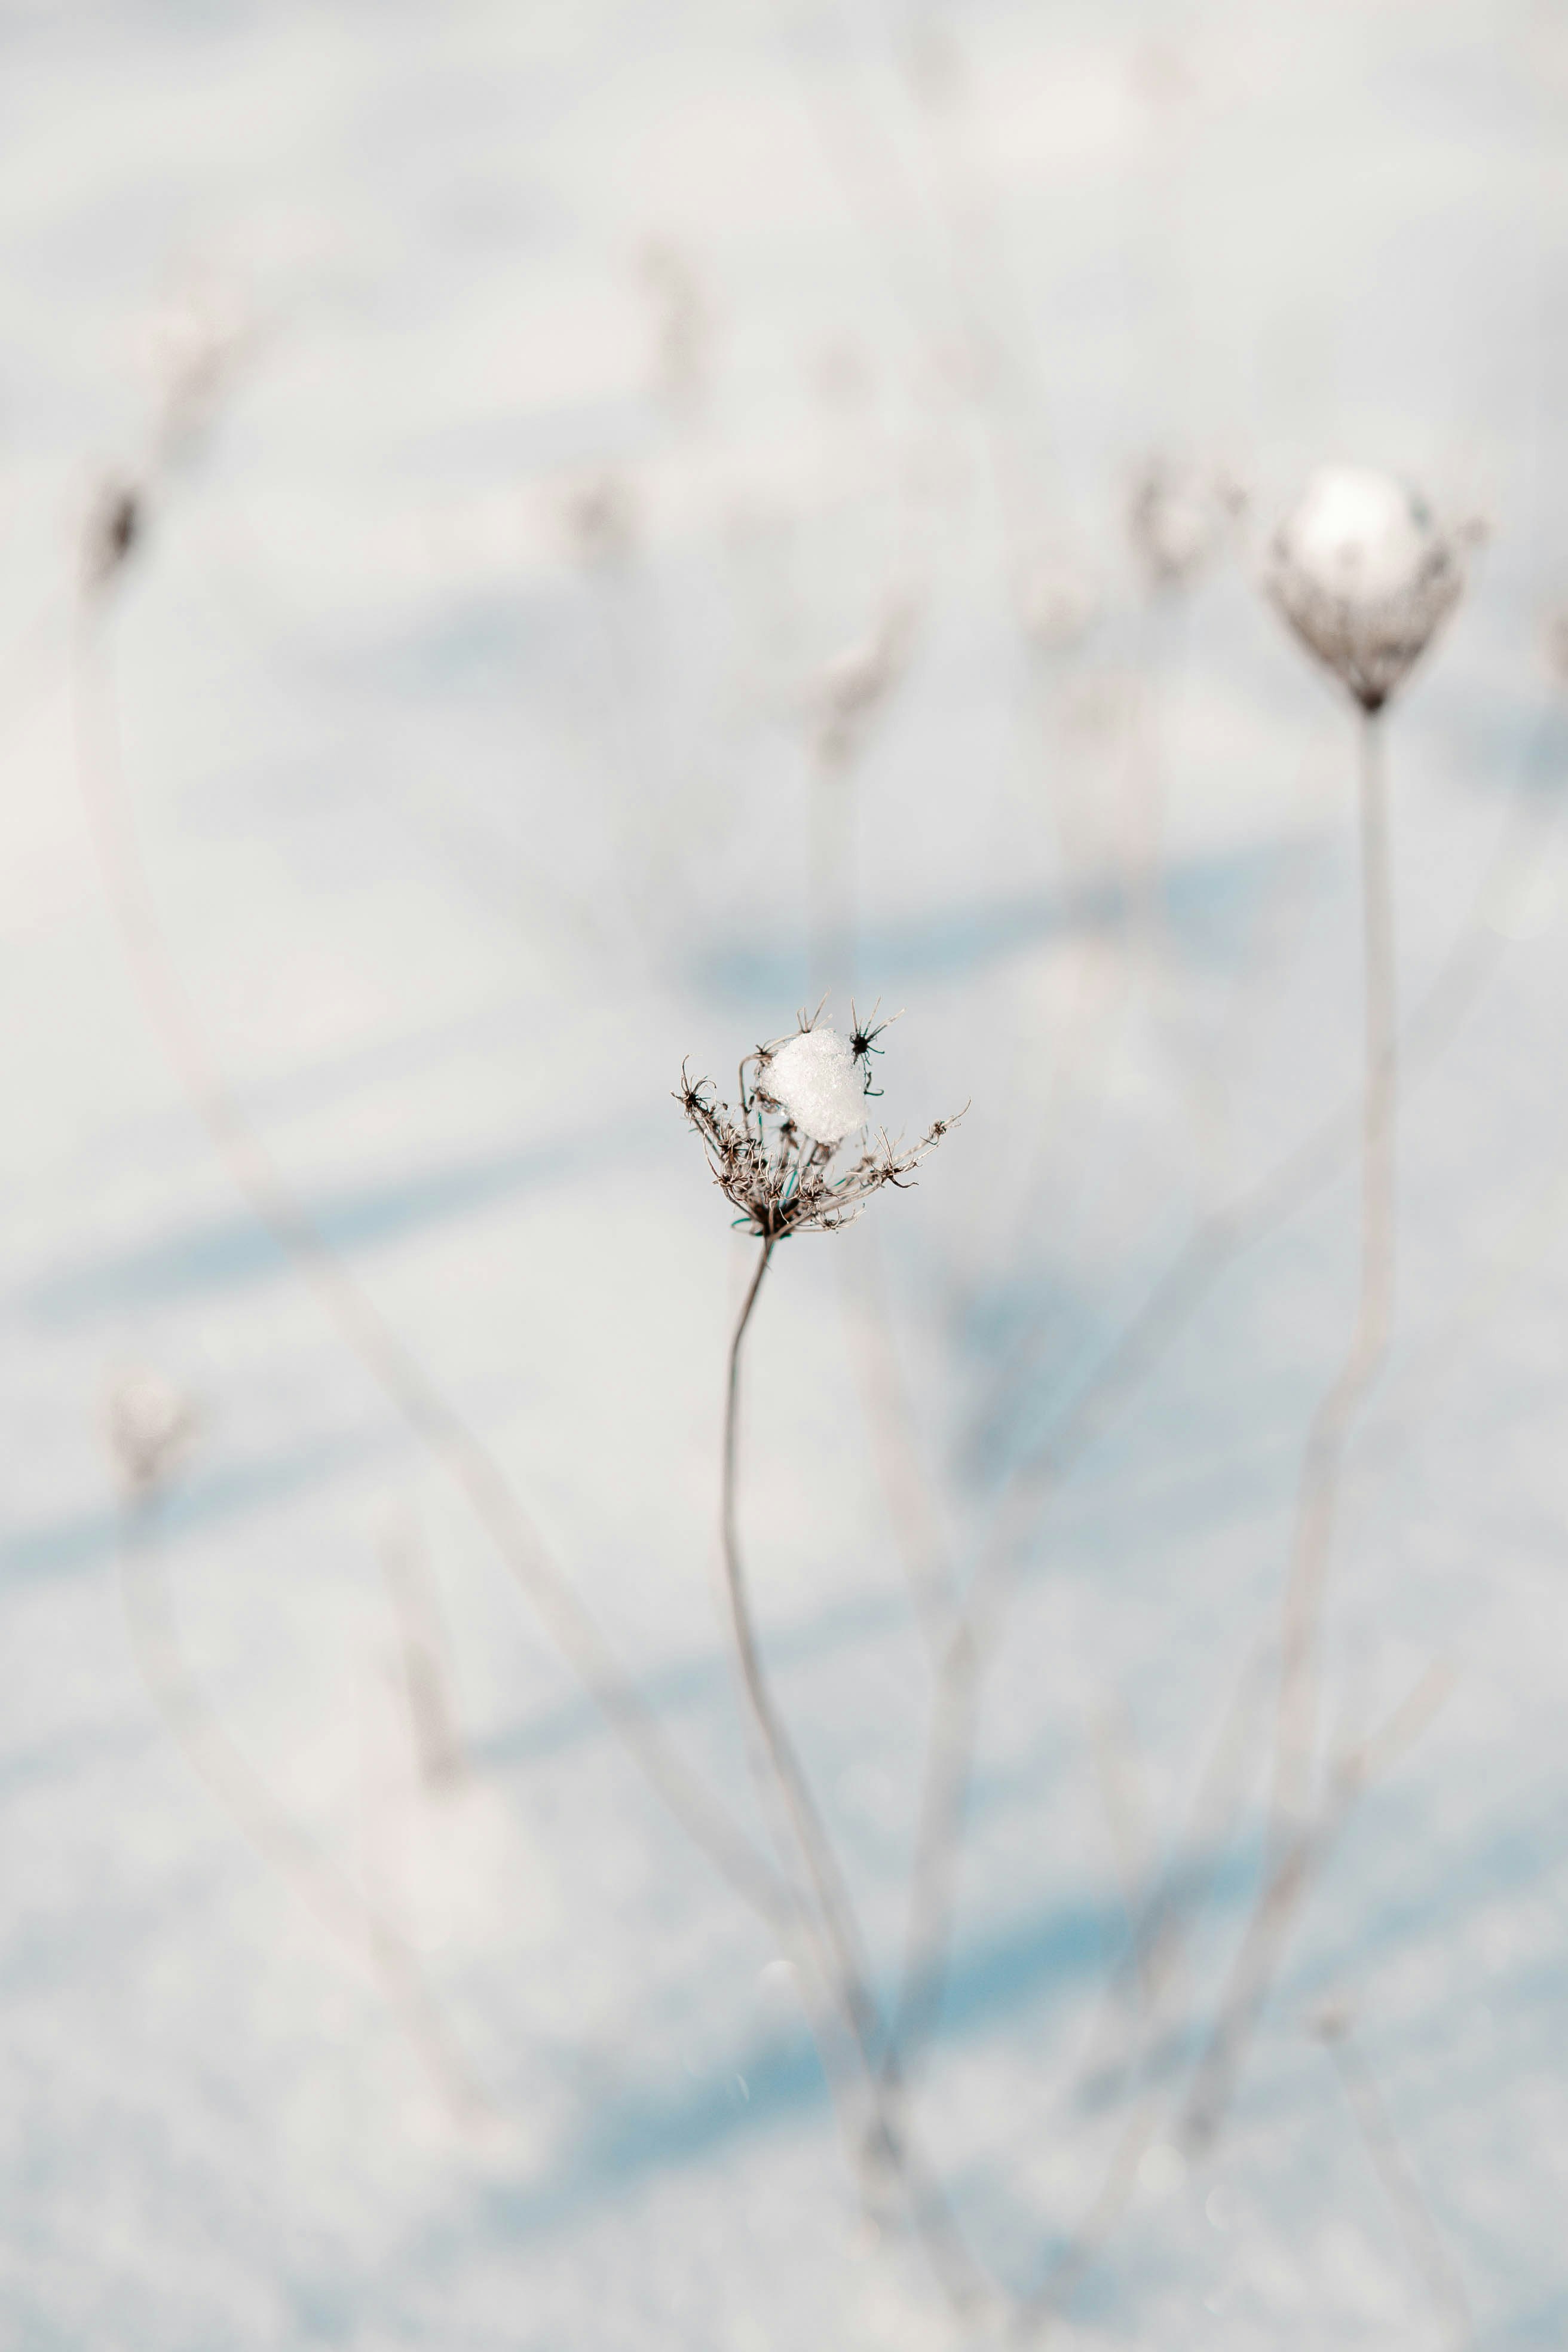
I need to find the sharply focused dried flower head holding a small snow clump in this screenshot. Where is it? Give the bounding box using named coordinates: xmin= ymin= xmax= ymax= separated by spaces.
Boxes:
xmin=675 ymin=1013 xmax=961 ymax=1242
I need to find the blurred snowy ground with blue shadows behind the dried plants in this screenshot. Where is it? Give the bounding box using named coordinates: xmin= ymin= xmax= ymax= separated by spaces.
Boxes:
xmin=0 ymin=0 xmax=1568 ymax=2352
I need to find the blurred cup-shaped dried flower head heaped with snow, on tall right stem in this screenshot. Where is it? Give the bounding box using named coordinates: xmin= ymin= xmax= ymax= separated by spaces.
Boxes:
xmin=1267 ymin=466 xmax=1474 ymax=710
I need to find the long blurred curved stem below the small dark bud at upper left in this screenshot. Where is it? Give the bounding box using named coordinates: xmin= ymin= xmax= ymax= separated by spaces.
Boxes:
xmin=73 ymin=607 xmax=790 ymax=1927
